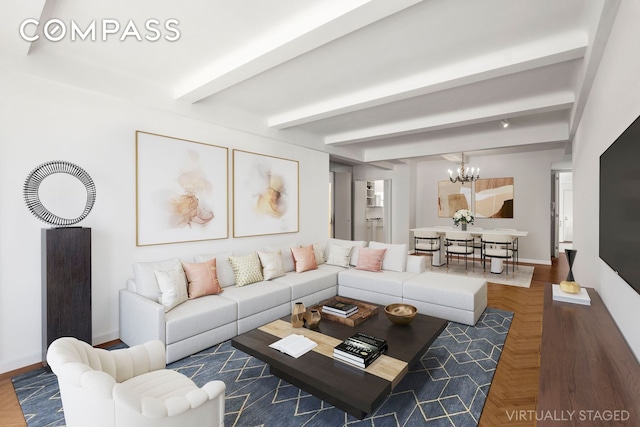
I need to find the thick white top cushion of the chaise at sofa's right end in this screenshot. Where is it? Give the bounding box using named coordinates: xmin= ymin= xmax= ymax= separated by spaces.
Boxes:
xmin=403 ymin=272 xmax=487 ymax=311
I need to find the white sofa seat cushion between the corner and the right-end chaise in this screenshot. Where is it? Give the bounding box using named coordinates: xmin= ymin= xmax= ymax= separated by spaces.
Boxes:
xmin=338 ymin=269 xmax=416 ymax=297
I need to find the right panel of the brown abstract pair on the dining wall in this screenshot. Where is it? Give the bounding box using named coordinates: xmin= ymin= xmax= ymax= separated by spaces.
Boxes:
xmin=475 ymin=177 xmax=513 ymax=218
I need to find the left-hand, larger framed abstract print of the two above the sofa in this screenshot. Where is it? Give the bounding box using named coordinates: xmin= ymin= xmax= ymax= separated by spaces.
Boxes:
xmin=136 ymin=131 xmax=229 ymax=246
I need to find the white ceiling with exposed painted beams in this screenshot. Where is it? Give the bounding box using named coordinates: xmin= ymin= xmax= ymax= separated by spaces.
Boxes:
xmin=0 ymin=0 xmax=620 ymax=167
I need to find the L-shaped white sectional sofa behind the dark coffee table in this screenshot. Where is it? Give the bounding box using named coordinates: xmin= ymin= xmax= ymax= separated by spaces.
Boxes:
xmin=120 ymin=239 xmax=486 ymax=363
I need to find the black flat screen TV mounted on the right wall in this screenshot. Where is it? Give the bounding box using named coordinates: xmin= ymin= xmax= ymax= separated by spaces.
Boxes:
xmin=599 ymin=113 xmax=640 ymax=294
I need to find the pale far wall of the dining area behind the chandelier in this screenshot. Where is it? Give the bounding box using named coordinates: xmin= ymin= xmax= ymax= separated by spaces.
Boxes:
xmin=415 ymin=150 xmax=564 ymax=264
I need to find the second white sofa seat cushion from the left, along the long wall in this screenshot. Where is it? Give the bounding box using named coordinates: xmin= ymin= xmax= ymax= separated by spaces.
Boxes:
xmin=222 ymin=279 xmax=291 ymax=319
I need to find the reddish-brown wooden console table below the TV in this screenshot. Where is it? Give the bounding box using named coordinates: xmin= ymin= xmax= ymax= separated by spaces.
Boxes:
xmin=534 ymin=284 xmax=640 ymax=427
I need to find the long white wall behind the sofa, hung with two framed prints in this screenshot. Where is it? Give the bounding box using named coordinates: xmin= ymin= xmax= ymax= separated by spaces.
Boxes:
xmin=0 ymin=70 xmax=329 ymax=372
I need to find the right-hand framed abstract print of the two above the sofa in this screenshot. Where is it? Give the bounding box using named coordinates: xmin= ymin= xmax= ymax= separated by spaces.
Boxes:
xmin=233 ymin=150 xmax=299 ymax=237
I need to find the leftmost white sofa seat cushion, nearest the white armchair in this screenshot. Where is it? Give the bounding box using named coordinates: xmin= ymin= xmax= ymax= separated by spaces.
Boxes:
xmin=166 ymin=291 xmax=238 ymax=344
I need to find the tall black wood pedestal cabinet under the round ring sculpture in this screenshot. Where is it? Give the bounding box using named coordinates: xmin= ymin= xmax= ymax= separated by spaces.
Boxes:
xmin=42 ymin=227 xmax=92 ymax=361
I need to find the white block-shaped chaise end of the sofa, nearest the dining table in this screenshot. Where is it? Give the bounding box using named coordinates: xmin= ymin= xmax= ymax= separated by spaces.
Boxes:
xmin=402 ymin=271 xmax=487 ymax=326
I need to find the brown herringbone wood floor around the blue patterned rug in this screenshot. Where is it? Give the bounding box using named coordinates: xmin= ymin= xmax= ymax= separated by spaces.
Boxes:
xmin=0 ymin=257 xmax=568 ymax=427
